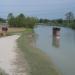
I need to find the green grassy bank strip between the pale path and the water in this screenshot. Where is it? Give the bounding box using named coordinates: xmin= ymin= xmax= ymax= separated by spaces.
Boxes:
xmin=18 ymin=29 xmax=60 ymax=75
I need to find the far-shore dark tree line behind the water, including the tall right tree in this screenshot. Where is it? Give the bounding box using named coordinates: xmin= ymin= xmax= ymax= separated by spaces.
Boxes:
xmin=39 ymin=12 xmax=75 ymax=29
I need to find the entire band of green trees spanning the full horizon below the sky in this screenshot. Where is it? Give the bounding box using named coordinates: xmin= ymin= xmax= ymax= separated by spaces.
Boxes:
xmin=0 ymin=12 xmax=75 ymax=29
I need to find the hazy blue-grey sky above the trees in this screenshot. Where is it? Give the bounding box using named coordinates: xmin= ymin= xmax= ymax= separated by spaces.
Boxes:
xmin=0 ymin=0 xmax=75 ymax=19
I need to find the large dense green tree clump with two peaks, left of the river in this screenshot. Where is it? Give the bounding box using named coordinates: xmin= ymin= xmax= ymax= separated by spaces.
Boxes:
xmin=8 ymin=13 xmax=38 ymax=28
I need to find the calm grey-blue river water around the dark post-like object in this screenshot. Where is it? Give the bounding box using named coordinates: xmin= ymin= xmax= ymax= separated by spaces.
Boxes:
xmin=34 ymin=25 xmax=75 ymax=75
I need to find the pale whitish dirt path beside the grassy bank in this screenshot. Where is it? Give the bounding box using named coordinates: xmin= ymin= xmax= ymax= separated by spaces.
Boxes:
xmin=0 ymin=35 xmax=26 ymax=75
